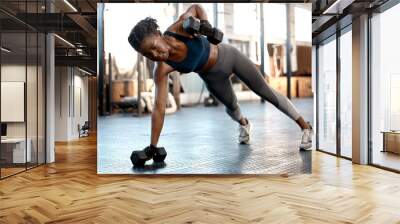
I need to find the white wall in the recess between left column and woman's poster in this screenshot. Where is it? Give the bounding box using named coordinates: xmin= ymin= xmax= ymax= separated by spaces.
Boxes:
xmin=55 ymin=67 xmax=88 ymax=141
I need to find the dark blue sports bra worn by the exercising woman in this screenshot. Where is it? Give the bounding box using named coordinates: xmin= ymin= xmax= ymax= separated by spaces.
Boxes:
xmin=164 ymin=31 xmax=210 ymax=73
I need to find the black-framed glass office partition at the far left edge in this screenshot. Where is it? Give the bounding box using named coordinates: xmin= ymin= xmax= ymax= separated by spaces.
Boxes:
xmin=0 ymin=1 xmax=46 ymax=178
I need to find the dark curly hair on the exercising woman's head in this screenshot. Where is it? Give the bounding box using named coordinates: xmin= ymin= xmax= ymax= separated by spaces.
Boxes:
xmin=128 ymin=17 xmax=161 ymax=51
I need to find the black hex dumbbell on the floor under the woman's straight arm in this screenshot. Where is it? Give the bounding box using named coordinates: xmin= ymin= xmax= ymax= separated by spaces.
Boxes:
xmin=131 ymin=145 xmax=167 ymax=167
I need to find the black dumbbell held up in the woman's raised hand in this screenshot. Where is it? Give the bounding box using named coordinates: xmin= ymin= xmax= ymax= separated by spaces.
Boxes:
xmin=183 ymin=16 xmax=224 ymax=44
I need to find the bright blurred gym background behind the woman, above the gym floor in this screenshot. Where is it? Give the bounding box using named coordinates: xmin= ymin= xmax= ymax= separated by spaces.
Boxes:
xmin=98 ymin=3 xmax=313 ymax=116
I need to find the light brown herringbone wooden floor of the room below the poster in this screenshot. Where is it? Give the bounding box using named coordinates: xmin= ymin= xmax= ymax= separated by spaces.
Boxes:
xmin=0 ymin=137 xmax=400 ymax=224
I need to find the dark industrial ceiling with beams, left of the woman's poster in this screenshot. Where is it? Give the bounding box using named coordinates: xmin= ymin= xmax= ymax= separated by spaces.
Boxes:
xmin=0 ymin=0 xmax=97 ymax=73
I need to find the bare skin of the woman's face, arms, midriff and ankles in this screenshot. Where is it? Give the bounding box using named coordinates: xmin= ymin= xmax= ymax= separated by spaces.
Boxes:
xmin=139 ymin=4 xmax=310 ymax=146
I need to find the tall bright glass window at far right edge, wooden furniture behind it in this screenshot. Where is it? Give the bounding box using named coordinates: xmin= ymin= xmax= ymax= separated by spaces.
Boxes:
xmin=370 ymin=5 xmax=400 ymax=170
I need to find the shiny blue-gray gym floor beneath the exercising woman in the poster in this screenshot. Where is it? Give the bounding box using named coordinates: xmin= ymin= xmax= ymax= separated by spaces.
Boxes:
xmin=97 ymin=98 xmax=313 ymax=175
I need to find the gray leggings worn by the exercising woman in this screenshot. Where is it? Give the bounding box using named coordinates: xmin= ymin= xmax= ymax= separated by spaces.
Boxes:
xmin=199 ymin=44 xmax=300 ymax=121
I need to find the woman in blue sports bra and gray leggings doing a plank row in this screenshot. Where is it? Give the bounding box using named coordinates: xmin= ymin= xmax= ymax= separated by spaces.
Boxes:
xmin=128 ymin=4 xmax=312 ymax=150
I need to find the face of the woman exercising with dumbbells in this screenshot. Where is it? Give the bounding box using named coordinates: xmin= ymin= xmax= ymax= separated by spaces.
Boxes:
xmin=140 ymin=34 xmax=169 ymax=61
